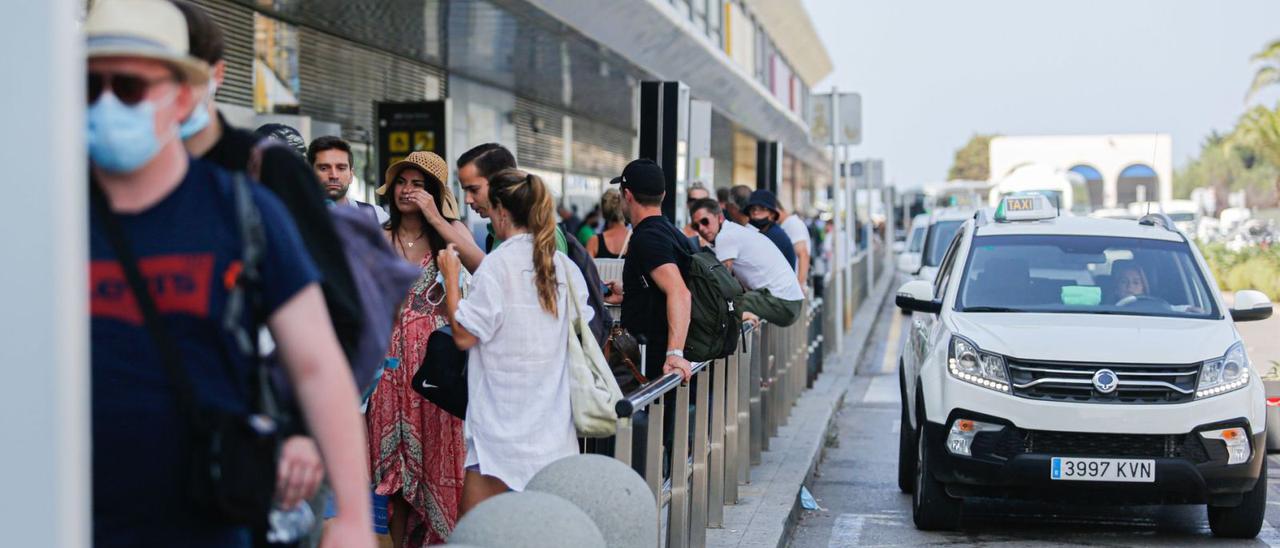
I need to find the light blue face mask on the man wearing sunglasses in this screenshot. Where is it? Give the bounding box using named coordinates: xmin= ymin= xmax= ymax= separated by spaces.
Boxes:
xmin=87 ymin=91 xmax=175 ymax=173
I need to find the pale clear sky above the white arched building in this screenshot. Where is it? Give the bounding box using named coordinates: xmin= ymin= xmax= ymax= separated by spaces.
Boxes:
xmin=804 ymin=0 xmax=1280 ymax=183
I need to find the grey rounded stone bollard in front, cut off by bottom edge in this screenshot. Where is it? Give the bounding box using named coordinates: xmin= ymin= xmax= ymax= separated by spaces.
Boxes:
xmin=448 ymin=492 xmax=604 ymax=548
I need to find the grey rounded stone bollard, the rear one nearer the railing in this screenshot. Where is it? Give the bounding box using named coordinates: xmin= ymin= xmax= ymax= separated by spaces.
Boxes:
xmin=526 ymin=455 xmax=658 ymax=548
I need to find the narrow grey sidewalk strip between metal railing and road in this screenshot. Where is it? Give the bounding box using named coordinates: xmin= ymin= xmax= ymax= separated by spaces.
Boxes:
xmin=707 ymin=270 xmax=897 ymax=548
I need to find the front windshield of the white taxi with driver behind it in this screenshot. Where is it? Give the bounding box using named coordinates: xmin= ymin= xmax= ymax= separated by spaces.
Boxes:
xmin=956 ymin=234 xmax=1219 ymax=319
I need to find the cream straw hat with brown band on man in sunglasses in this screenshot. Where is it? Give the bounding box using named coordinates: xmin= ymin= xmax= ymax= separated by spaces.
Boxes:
xmin=84 ymin=0 xmax=209 ymax=86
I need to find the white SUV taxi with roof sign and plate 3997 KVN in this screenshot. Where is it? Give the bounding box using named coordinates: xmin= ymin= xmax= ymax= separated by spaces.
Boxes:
xmin=896 ymin=196 xmax=1271 ymax=538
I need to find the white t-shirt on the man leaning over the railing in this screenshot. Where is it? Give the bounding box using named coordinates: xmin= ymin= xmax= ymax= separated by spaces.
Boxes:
xmin=714 ymin=220 xmax=804 ymax=301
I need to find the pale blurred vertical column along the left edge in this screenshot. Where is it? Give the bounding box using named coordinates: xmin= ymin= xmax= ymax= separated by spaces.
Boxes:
xmin=0 ymin=0 xmax=88 ymax=548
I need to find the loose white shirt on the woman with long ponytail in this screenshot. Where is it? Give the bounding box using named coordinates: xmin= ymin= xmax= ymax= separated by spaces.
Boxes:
xmin=456 ymin=234 xmax=593 ymax=490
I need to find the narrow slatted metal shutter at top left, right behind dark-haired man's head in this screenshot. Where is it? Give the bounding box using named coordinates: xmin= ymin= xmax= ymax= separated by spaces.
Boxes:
xmin=191 ymin=0 xmax=253 ymax=109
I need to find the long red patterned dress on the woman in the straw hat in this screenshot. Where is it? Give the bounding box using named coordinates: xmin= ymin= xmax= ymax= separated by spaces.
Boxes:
xmin=366 ymin=254 xmax=466 ymax=547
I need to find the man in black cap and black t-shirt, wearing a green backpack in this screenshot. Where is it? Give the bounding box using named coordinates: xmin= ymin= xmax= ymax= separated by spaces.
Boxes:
xmin=609 ymin=160 xmax=692 ymax=380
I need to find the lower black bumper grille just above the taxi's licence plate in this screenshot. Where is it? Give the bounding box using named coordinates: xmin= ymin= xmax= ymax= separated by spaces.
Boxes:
xmin=973 ymin=428 xmax=1226 ymax=463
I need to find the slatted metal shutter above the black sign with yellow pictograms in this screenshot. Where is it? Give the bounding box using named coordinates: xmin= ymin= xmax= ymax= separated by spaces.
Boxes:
xmin=298 ymin=27 xmax=448 ymax=141
